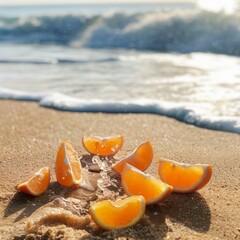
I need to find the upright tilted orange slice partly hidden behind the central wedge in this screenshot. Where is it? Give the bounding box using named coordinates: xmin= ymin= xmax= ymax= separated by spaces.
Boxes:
xmin=112 ymin=141 xmax=153 ymax=175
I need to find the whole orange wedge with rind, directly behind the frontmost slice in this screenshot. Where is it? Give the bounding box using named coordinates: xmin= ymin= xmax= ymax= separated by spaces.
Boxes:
xmin=121 ymin=164 xmax=173 ymax=205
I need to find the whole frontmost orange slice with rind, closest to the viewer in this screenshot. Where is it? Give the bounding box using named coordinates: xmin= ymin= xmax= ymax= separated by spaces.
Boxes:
xmin=89 ymin=196 xmax=146 ymax=230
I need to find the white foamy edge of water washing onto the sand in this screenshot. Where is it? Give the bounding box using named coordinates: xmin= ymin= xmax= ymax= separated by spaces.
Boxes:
xmin=0 ymin=88 xmax=240 ymax=133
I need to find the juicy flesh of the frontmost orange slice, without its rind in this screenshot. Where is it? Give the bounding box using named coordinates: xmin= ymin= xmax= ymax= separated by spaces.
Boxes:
xmin=90 ymin=198 xmax=142 ymax=227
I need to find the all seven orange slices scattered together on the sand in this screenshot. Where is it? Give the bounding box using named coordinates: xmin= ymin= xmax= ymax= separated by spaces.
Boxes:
xmin=18 ymin=135 xmax=212 ymax=230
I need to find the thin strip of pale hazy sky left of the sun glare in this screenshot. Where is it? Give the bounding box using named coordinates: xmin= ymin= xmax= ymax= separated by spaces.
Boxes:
xmin=0 ymin=0 xmax=195 ymax=5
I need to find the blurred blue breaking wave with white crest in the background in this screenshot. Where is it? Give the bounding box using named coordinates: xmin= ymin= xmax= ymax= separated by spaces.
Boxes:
xmin=0 ymin=10 xmax=240 ymax=56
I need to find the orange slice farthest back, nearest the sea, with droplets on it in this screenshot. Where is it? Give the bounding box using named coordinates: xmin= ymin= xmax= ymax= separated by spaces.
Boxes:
xmin=82 ymin=135 xmax=124 ymax=156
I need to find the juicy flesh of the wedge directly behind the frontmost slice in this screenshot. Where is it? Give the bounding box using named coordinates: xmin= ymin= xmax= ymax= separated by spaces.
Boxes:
xmin=122 ymin=170 xmax=166 ymax=201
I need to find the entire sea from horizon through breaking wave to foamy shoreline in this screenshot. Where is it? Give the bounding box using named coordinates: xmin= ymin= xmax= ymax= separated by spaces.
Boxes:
xmin=0 ymin=4 xmax=240 ymax=133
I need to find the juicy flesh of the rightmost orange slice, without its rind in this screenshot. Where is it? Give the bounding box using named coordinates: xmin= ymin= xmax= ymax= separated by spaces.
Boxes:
xmin=161 ymin=162 xmax=204 ymax=188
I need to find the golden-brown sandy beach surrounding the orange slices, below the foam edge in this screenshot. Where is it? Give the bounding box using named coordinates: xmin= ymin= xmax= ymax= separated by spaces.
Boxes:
xmin=0 ymin=100 xmax=240 ymax=239
